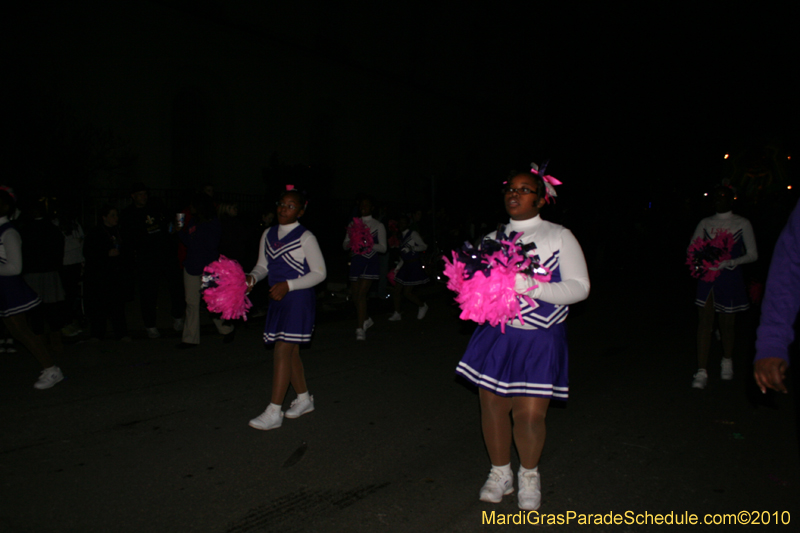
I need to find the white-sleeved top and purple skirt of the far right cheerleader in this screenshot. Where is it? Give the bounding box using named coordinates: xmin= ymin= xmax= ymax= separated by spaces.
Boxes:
xmin=692 ymin=212 xmax=758 ymax=313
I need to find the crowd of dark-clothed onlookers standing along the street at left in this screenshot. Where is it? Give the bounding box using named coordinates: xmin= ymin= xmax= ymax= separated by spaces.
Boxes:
xmin=0 ymin=183 xmax=272 ymax=354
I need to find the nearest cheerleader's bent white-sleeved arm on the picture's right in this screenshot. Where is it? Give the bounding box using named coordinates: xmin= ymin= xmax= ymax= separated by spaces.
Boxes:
xmin=531 ymin=229 xmax=590 ymax=305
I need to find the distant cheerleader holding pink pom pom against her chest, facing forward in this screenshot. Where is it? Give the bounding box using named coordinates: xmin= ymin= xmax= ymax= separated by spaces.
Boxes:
xmin=343 ymin=198 xmax=386 ymax=341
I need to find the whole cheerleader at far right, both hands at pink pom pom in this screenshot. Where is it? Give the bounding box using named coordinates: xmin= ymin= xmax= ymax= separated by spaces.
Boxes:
xmin=692 ymin=185 xmax=758 ymax=389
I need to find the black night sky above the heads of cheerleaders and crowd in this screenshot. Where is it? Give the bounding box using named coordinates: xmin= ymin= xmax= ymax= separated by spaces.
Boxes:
xmin=3 ymin=0 xmax=800 ymax=274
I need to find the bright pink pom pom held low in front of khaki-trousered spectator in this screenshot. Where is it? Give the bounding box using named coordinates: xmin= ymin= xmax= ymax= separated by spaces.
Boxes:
xmin=201 ymin=255 xmax=253 ymax=320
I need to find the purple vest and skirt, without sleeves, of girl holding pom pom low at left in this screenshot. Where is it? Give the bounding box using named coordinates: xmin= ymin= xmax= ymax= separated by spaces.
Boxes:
xmin=264 ymin=225 xmax=317 ymax=344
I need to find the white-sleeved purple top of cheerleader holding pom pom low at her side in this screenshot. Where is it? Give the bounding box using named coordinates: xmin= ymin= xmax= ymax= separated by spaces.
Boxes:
xmin=250 ymin=222 xmax=327 ymax=292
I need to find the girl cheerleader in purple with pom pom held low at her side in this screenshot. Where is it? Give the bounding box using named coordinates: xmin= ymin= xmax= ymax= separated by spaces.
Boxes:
xmin=247 ymin=185 xmax=326 ymax=430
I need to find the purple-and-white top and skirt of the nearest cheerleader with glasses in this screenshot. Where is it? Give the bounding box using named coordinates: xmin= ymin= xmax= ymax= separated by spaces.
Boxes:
xmin=456 ymin=216 xmax=589 ymax=400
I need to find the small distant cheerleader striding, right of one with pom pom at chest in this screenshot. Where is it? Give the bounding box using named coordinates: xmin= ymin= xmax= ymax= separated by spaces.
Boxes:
xmin=389 ymin=215 xmax=428 ymax=321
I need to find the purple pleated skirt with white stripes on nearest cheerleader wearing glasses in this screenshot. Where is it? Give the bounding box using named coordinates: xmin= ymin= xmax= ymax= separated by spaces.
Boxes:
xmin=456 ymin=323 xmax=569 ymax=400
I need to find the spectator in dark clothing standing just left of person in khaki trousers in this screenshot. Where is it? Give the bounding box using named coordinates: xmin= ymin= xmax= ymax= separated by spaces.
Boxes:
xmin=120 ymin=182 xmax=183 ymax=339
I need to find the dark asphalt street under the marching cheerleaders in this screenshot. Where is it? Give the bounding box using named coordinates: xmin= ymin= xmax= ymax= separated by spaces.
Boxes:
xmin=0 ymin=274 xmax=800 ymax=533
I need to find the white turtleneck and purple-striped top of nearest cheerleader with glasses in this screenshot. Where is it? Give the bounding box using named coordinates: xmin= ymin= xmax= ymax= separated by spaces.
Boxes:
xmin=487 ymin=215 xmax=590 ymax=329
